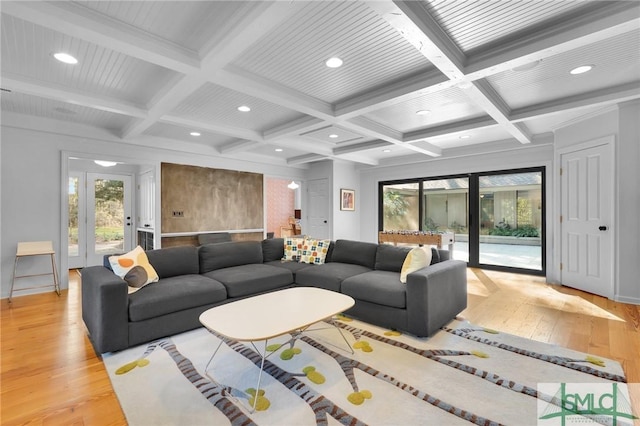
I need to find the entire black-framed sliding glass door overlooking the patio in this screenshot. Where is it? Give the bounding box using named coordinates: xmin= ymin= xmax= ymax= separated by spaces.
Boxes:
xmin=379 ymin=168 xmax=545 ymax=275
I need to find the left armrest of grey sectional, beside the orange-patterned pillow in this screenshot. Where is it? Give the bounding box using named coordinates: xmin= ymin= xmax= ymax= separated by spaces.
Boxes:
xmin=82 ymin=266 xmax=129 ymax=353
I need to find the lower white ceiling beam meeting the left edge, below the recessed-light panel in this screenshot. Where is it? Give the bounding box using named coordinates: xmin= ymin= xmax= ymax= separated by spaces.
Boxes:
xmin=2 ymin=72 xmax=148 ymax=118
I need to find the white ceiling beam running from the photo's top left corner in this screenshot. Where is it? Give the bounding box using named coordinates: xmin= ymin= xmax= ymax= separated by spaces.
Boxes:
xmin=2 ymin=1 xmax=200 ymax=73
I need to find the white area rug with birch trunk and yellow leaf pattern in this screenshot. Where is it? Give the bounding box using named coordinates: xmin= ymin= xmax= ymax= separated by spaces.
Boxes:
xmin=103 ymin=316 xmax=633 ymax=426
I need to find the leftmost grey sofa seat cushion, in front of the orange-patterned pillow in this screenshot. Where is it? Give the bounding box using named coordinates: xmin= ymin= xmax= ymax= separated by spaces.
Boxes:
xmin=129 ymin=274 xmax=227 ymax=321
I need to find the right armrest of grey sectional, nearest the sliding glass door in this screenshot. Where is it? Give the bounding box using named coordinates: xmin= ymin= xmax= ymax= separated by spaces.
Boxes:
xmin=407 ymin=260 xmax=467 ymax=337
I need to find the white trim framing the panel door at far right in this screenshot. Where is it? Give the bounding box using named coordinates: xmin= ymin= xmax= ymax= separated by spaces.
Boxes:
xmin=553 ymin=135 xmax=620 ymax=300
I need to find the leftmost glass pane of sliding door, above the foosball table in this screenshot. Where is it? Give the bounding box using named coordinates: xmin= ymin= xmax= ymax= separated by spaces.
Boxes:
xmin=382 ymin=183 xmax=419 ymax=231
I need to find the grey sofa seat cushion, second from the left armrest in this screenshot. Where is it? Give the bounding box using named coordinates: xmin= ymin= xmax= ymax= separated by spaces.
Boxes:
xmin=204 ymin=264 xmax=293 ymax=297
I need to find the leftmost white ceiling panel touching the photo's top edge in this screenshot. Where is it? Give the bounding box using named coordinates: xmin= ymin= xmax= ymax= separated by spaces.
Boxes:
xmin=75 ymin=0 xmax=251 ymax=52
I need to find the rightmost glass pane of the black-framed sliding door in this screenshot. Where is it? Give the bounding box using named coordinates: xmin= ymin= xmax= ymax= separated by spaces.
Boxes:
xmin=479 ymin=172 xmax=542 ymax=270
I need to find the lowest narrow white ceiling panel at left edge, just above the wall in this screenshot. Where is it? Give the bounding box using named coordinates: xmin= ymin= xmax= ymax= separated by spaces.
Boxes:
xmin=0 ymin=92 xmax=131 ymax=131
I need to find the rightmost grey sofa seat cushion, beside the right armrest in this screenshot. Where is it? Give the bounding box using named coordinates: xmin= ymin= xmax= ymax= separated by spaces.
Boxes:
xmin=340 ymin=271 xmax=407 ymax=309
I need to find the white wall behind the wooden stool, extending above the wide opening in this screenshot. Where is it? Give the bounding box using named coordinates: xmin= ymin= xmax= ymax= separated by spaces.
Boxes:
xmin=0 ymin=121 xmax=306 ymax=298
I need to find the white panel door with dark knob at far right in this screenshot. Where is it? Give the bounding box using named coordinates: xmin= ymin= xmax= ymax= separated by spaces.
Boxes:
xmin=560 ymin=144 xmax=614 ymax=298
